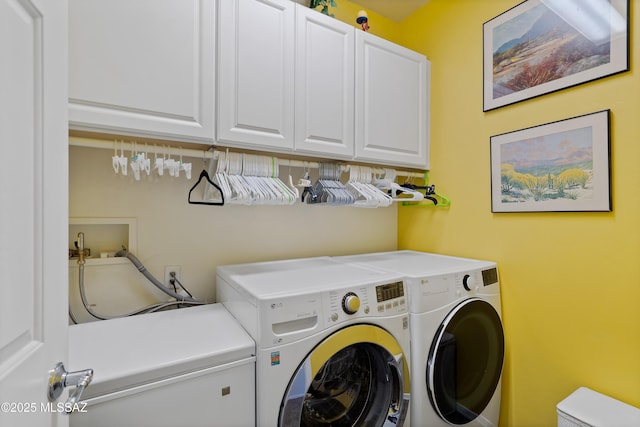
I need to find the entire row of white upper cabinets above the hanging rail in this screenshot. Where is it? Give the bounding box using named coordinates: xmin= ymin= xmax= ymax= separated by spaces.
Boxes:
xmin=69 ymin=0 xmax=429 ymax=169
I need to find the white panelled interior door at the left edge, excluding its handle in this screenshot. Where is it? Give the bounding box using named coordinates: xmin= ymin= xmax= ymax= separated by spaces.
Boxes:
xmin=0 ymin=0 xmax=69 ymax=427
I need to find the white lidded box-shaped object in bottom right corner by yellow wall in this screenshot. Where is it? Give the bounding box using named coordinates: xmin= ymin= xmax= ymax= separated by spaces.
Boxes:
xmin=556 ymin=387 xmax=640 ymax=427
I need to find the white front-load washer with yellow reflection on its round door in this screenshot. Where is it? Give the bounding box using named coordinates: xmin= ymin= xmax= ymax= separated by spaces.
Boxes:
xmin=216 ymin=257 xmax=410 ymax=427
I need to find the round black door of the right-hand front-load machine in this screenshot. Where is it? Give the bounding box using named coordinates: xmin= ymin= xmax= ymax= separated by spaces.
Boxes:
xmin=426 ymin=298 xmax=504 ymax=424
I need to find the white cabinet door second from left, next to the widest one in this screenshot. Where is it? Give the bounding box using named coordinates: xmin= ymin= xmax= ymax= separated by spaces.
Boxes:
xmin=217 ymin=0 xmax=295 ymax=151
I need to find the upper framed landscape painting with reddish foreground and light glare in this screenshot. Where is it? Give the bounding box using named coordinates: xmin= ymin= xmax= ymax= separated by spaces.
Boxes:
xmin=483 ymin=0 xmax=629 ymax=111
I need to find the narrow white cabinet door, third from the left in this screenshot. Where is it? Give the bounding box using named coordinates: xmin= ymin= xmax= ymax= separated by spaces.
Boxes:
xmin=295 ymin=5 xmax=355 ymax=158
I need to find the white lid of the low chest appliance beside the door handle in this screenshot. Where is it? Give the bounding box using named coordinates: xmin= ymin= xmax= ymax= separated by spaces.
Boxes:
xmin=67 ymin=304 xmax=255 ymax=399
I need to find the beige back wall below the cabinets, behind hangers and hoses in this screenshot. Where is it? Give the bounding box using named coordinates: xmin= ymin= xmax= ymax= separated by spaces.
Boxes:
xmin=69 ymin=147 xmax=397 ymax=322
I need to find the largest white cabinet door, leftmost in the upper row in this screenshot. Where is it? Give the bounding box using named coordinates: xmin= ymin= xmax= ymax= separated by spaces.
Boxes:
xmin=69 ymin=0 xmax=215 ymax=142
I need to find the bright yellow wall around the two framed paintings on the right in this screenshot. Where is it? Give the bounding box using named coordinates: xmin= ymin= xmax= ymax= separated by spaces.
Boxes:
xmin=398 ymin=0 xmax=640 ymax=427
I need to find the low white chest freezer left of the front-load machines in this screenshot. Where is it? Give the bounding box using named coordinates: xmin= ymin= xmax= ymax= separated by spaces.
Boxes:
xmin=67 ymin=304 xmax=255 ymax=427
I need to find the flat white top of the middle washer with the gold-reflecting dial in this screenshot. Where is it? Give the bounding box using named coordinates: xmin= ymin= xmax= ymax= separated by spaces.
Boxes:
xmin=216 ymin=257 xmax=402 ymax=299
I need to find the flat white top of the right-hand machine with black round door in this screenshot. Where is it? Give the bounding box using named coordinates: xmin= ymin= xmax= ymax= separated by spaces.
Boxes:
xmin=336 ymin=251 xmax=496 ymax=277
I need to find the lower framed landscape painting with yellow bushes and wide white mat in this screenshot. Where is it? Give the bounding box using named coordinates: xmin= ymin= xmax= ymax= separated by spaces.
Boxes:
xmin=491 ymin=110 xmax=611 ymax=212
